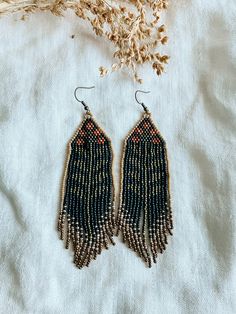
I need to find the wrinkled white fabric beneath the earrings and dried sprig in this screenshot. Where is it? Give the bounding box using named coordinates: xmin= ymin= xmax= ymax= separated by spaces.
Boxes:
xmin=0 ymin=0 xmax=236 ymax=314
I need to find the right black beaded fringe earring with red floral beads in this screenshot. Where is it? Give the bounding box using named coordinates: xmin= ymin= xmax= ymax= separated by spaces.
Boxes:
xmin=117 ymin=90 xmax=173 ymax=267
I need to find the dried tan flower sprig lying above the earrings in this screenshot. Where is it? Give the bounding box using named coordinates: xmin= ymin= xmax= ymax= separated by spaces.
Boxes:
xmin=0 ymin=0 xmax=169 ymax=83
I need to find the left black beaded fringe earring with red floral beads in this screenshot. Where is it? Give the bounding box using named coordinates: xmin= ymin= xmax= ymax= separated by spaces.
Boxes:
xmin=58 ymin=86 xmax=115 ymax=268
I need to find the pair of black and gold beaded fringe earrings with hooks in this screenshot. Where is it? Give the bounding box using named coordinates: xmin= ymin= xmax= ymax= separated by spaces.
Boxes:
xmin=58 ymin=87 xmax=173 ymax=268
